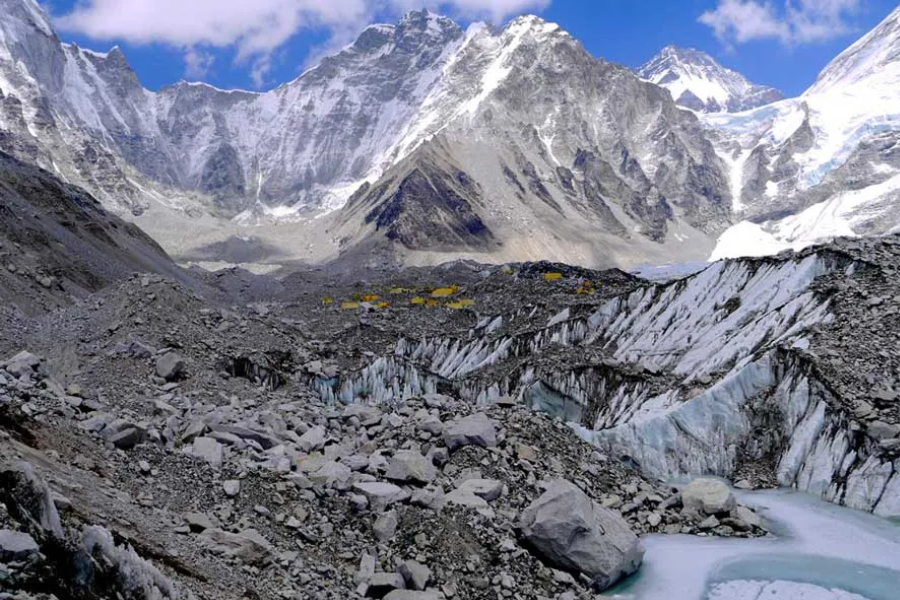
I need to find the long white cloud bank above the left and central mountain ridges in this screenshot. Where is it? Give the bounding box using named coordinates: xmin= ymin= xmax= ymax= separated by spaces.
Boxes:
xmin=56 ymin=0 xmax=551 ymax=84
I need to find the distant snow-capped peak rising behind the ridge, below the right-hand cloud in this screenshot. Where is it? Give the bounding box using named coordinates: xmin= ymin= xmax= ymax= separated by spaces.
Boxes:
xmin=637 ymin=46 xmax=784 ymax=113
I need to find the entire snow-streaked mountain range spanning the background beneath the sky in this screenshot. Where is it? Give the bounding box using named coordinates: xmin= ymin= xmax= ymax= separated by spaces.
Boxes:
xmin=0 ymin=0 xmax=897 ymax=267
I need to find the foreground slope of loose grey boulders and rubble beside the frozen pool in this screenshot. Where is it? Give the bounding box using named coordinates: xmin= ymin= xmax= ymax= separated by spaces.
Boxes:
xmin=0 ymin=342 xmax=763 ymax=600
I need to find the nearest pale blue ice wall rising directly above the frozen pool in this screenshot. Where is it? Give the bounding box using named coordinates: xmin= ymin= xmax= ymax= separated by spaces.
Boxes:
xmin=573 ymin=350 xmax=900 ymax=517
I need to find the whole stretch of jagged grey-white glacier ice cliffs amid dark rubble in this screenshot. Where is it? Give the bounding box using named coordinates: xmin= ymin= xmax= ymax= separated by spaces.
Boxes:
xmin=306 ymin=252 xmax=900 ymax=516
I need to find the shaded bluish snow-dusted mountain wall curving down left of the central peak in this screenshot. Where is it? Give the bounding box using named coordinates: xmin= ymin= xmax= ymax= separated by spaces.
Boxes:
xmin=0 ymin=0 xmax=463 ymax=216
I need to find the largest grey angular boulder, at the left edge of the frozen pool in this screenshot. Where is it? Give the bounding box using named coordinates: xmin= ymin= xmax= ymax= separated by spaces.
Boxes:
xmin=519 ymin=479 xmax=644 ymax=591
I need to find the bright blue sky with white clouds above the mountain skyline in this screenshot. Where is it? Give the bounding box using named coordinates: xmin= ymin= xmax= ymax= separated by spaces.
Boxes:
xmin=39 ymin=0 xmax=897 ymax=95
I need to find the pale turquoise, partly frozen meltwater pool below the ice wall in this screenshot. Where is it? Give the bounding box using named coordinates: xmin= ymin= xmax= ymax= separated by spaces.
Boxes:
xmin=606 ymin=491 xmax=900 ymax=600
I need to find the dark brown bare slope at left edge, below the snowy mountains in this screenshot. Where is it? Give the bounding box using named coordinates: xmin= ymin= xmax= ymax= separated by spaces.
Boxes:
xmin=0 ymin=152 xmax=189 ymax=314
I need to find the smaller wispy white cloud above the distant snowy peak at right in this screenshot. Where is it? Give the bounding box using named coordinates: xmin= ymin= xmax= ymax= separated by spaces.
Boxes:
xmin=698 ymin=0 xmax=862 ymax=44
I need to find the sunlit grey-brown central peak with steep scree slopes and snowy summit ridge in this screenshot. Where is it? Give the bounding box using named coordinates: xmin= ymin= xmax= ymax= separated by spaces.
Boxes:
xmin=330 ymin=17 xmax=730 ymax=264
